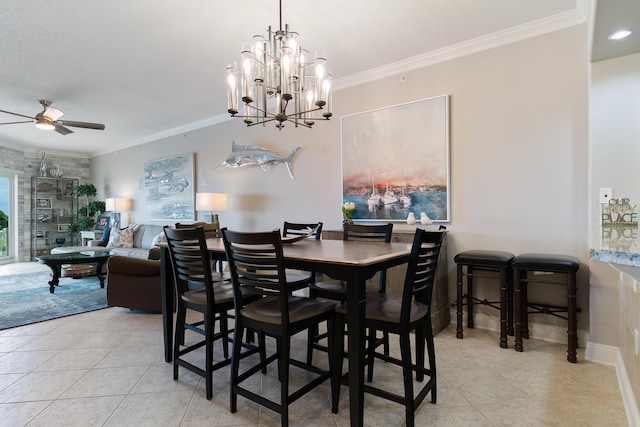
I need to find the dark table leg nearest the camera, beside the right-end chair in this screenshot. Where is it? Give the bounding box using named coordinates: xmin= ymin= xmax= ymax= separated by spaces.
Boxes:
xmin=347 ymin=277 xmax=365 ymax=426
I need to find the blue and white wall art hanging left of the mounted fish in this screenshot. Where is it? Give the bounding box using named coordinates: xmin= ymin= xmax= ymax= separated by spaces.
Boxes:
xmin=144 ymin=153 xmax=195 ymax=222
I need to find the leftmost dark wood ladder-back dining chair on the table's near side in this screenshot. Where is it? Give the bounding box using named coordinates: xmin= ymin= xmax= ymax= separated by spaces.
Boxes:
xmin=164 ymin=227 xmax=265 ymax=399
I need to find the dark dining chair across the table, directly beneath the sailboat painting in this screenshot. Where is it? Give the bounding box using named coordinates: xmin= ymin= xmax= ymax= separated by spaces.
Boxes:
xmin=307 ymin=223 xmax=393 ymax=363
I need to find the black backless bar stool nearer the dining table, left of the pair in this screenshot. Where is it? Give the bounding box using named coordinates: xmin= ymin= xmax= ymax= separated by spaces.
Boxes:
xmin=453 ymin=250 xmax=515 ymax=348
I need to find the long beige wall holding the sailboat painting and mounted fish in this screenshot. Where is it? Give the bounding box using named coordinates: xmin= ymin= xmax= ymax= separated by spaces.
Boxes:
xmin=91 ymin=24 xmax=588 ymax=329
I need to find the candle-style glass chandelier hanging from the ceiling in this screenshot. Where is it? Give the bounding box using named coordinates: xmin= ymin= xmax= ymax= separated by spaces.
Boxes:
xmin=227 ymin=0 xmax=332 ymax=130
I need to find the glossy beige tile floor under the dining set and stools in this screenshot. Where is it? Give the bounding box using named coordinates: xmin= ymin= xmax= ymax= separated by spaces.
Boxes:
xmin=0 ymin=262 xmax=627 ymax=427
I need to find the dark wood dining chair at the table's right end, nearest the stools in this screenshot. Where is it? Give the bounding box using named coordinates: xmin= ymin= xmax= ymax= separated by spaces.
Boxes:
xmin=332 ymin=229 xmax=444 ymax=427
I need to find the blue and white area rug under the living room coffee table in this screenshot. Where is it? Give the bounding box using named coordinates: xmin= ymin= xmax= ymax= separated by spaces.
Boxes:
xmin=0 ymin=273 xmax=107 ymax=330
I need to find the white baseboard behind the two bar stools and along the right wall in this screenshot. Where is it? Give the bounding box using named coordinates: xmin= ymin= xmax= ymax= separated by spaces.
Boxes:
xmin=451 ymin=309 xmax=640 ymax=426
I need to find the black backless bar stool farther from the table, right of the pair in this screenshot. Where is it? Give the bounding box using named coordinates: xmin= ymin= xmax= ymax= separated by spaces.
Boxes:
xmin=513 ymin=254 xmax=580 ymax=363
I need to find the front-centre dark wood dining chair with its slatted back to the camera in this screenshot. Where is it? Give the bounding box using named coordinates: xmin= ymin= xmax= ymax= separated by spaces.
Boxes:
xmin=222 ymin=228 xmax=335 ymax=426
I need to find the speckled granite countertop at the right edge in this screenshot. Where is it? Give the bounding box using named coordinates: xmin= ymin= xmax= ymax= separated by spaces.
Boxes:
xmin=587 ymin=224 xmax=640 ymax=267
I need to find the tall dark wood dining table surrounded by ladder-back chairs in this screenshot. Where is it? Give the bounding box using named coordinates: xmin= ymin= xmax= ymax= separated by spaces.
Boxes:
xmin=158 ymin=238 xmax=411 ymax=426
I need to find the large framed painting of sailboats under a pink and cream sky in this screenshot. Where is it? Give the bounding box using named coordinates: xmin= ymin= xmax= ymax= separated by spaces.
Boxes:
xmin=342 ymin=95 xmax=450 ymax=222
